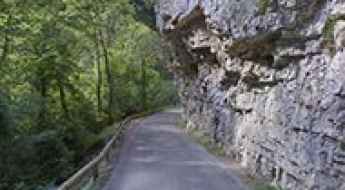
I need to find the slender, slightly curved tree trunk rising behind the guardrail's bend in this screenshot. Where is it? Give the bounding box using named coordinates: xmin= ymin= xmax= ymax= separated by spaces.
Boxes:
xmin=99 ymin=31 xmax=114 ymax=123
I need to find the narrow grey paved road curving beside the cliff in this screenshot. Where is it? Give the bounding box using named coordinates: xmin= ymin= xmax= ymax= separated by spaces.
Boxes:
xmin=103 ymin=112 xmax=246 ymax=190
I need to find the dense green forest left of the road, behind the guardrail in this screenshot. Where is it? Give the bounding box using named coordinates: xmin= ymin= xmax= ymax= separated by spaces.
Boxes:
xmin=0 ymin=0 xmax=178 ymax=190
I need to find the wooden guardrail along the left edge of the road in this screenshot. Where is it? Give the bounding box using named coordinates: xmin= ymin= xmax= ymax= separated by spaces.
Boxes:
xmin=57 ymin=114 xmax=144 ymax=190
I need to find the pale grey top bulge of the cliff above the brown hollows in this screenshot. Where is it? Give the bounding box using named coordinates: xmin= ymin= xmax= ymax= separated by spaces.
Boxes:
xmin=157 ymin=0 xmax=326 ymax=40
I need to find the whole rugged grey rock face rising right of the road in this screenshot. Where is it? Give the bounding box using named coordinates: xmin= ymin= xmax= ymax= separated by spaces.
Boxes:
xmin=157 ymin=0 xmax=345 ymax=190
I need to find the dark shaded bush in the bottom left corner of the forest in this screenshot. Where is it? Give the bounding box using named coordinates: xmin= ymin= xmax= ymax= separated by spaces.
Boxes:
xmin=0 ymin=131 xmax=73 ymax=190
